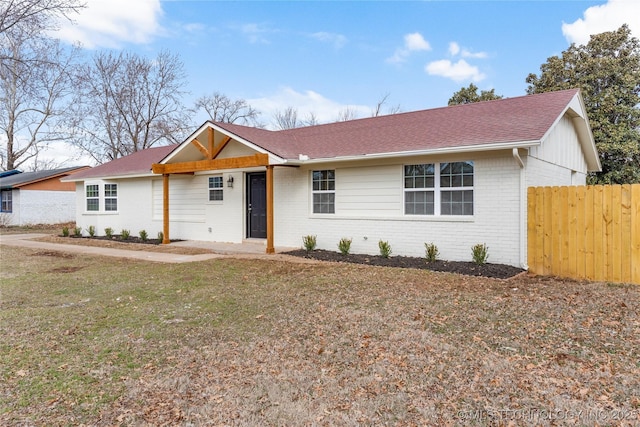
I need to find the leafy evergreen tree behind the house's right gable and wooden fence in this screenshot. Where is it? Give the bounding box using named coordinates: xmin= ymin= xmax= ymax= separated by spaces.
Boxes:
xmin=526 ymin=25 xmax=640 ymax=184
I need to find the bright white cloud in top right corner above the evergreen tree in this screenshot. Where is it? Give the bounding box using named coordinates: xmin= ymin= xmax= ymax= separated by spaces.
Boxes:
xmin=562 ymin=0 xmax=640 ymax=44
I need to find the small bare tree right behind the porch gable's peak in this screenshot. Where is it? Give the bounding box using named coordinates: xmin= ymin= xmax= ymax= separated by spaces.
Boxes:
xmin=195 ymin=92 xmax=260 ymax=125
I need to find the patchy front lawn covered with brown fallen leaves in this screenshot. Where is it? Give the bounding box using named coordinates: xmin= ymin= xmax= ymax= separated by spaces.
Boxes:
xmin=0 ymin=242 xmax=640 ymax=426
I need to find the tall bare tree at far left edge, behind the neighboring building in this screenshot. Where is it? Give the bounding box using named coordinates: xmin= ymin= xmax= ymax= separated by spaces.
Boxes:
xmin=0 ymin=27 xmax=78 ymax=170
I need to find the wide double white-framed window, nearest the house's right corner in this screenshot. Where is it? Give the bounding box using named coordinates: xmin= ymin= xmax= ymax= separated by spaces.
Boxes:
xmin=404 ymin=161 xmax=473 ymax=215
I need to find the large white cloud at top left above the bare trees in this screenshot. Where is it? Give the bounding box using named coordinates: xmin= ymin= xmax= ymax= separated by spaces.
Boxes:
xmin=54 ymin=0 xmax=163 ymax=49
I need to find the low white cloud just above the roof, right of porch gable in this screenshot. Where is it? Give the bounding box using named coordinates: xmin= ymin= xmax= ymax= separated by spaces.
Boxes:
xmin=247 ymin=87 xmax=371 ymax=128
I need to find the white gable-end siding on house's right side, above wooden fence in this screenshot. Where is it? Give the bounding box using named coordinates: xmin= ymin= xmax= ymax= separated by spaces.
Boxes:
xmin=527 ymin=115 xmax=587 ymax=186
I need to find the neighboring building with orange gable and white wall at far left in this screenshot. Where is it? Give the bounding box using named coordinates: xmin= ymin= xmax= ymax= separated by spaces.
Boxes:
xmin=0 ymin=166 xmax=89 ymax=225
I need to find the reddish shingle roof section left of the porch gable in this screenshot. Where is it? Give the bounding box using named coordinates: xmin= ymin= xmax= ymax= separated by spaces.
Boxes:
xmin=67 ymin=144 xmax=177 ymax=181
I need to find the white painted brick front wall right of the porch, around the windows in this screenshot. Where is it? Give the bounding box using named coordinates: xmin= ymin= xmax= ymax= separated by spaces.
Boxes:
xmin=274 ymin=153 xmax=520 ymax=265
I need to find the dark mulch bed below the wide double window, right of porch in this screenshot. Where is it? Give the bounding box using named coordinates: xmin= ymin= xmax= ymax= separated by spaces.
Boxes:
xmin=285 ymin=249 xmax=525 ymax=279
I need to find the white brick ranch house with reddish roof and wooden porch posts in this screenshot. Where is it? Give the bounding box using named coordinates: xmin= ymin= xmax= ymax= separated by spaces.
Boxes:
xmin=65 ymin=90 xmax=600 ymax=266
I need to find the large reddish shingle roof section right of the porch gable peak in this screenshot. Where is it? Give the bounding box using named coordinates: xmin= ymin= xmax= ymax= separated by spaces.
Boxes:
xmin=215 ymin=89 xmax=578 ymax=159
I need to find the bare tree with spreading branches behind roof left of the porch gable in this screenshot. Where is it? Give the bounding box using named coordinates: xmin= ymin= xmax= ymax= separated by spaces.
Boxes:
xmin=74 ymin=51 xmax=191 ymax=163
